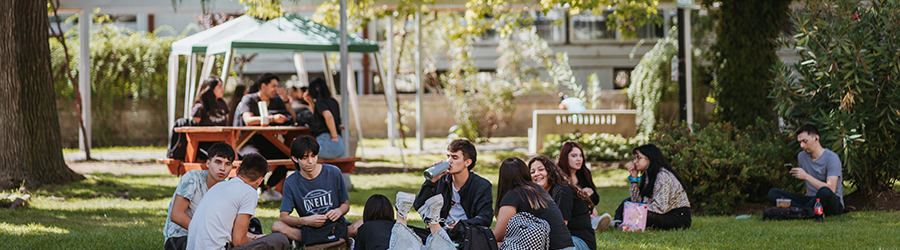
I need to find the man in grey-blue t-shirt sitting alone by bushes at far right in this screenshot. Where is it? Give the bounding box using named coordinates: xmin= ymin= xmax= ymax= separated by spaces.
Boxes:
xmin=769 ymin=123 xmax=844 ymax=216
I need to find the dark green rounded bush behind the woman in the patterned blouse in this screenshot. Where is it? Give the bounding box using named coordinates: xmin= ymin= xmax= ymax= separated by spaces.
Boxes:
xmin=650 ymin=121 xmax=803 ymax=214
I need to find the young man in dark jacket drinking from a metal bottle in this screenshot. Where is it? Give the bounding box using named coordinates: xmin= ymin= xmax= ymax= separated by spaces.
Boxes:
xmin=413 ymin=139 xmax=494 ymax=240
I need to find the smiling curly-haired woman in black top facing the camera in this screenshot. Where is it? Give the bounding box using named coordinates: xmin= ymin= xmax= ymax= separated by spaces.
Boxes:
xmin=528 ymin=155 xmax=608 ymax=250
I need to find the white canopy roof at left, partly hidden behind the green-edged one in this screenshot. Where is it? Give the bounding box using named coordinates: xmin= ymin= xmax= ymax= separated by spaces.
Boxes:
xmin=172 ymin=15 xmax=263 ymax=55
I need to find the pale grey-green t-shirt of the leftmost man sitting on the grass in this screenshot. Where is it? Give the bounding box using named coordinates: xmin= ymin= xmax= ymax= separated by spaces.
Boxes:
xmin=163 ymin=170 xmax=208 ymax=239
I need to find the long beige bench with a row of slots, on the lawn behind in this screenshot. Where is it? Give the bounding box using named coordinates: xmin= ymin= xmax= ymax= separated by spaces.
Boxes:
xmin=528 ymin=109 xmax=637 ymax=154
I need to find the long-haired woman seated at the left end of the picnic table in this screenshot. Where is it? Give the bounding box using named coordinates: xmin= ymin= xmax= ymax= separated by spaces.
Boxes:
xmin=191 ymin=76 xmax=229 ymax=126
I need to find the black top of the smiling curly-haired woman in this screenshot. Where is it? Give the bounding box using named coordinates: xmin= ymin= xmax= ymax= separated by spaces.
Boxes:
xmin=550 ymin=185 xmax=597 ymax=250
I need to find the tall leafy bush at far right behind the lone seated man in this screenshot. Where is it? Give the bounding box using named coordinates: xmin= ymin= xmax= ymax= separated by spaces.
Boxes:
xmin=770 ymin=0 xmax=900 ymax=200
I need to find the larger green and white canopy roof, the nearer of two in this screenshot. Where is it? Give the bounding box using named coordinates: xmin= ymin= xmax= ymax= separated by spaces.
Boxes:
xmin=206 ymin=16 xmax=378 ymax=54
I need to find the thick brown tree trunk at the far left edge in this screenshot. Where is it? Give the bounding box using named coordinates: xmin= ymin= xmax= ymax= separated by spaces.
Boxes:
xmin=0 ymin=0 xmax=84 ymax=190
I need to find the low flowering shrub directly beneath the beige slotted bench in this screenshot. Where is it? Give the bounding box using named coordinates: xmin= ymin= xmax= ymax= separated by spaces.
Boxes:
xmin=541 ymin=132 xmax=647 ymax=162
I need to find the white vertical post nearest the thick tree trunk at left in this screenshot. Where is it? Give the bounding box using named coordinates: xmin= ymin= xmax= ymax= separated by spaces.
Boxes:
xmin=78 ymin=7 xmax=94 ymax=151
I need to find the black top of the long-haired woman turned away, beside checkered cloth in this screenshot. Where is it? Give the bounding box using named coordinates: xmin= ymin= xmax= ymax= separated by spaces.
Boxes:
xmin=500 ymin=187 xmax=572 ymax=249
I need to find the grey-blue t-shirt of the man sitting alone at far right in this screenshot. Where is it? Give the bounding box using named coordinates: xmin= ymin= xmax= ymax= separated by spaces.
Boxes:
xmin=797 ymin=148 xmax=844 ymax=206
